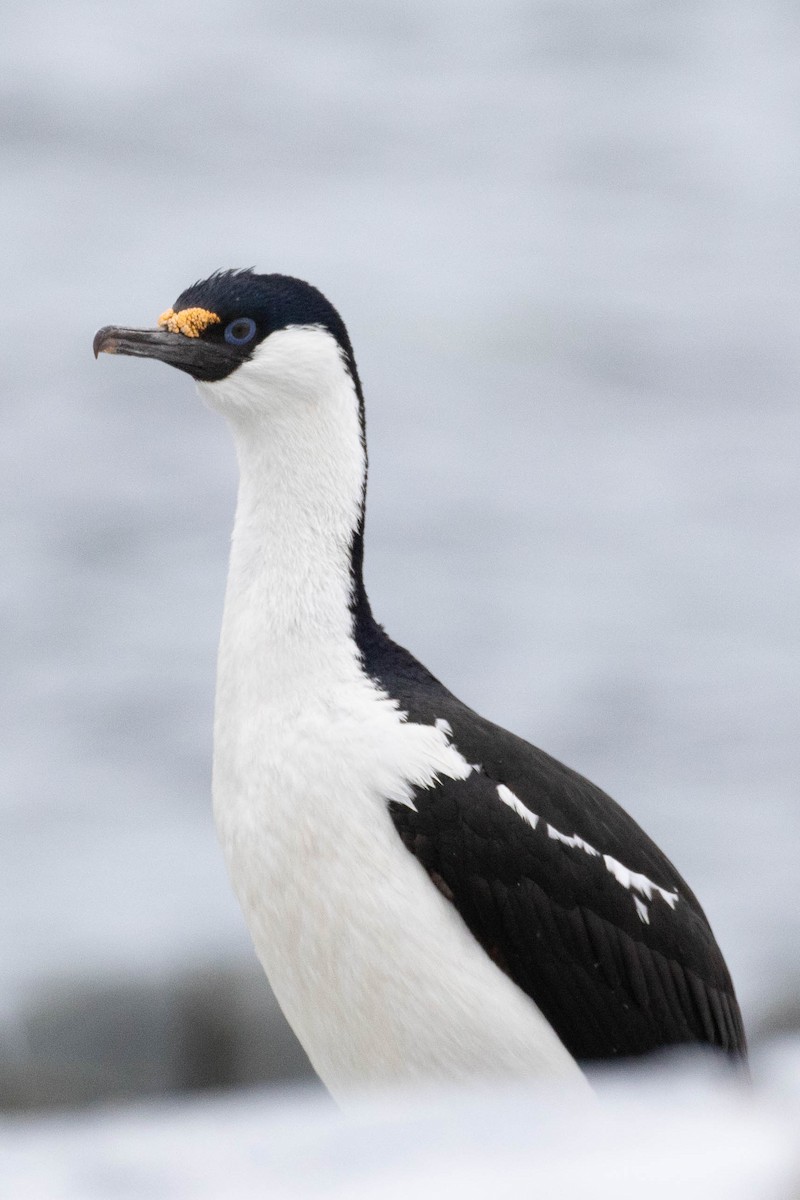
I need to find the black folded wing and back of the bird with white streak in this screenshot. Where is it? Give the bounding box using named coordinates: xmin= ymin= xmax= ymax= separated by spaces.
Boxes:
xmin=359 ymin=619 xmax=746 ymax=1061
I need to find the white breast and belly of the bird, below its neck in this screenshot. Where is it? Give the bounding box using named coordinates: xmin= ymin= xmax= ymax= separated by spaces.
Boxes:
xmin=215 ymin=685 xmax=583 ymax=1098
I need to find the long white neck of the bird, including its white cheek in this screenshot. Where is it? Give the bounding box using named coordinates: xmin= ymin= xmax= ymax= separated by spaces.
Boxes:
xmin=200 ymin=328 xmax=366 ymax=701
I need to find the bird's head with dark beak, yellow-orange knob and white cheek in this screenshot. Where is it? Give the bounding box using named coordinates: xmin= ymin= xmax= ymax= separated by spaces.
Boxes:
xmin=94 ymin=270 xmax=361 ymax=429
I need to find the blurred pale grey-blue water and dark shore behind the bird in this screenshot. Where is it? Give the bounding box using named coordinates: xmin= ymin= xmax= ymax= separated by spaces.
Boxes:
xmin=0 ymin=0 xmax=800 ymax=1180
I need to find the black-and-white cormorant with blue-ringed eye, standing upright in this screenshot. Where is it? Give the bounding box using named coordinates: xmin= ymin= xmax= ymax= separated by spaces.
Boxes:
xmin=94 ymin=268 xmax=746 ymax=1104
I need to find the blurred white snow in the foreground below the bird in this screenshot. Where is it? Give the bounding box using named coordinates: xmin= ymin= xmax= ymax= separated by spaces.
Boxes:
xmin=0 ymin=1043 xmax=800 ymax=1200
